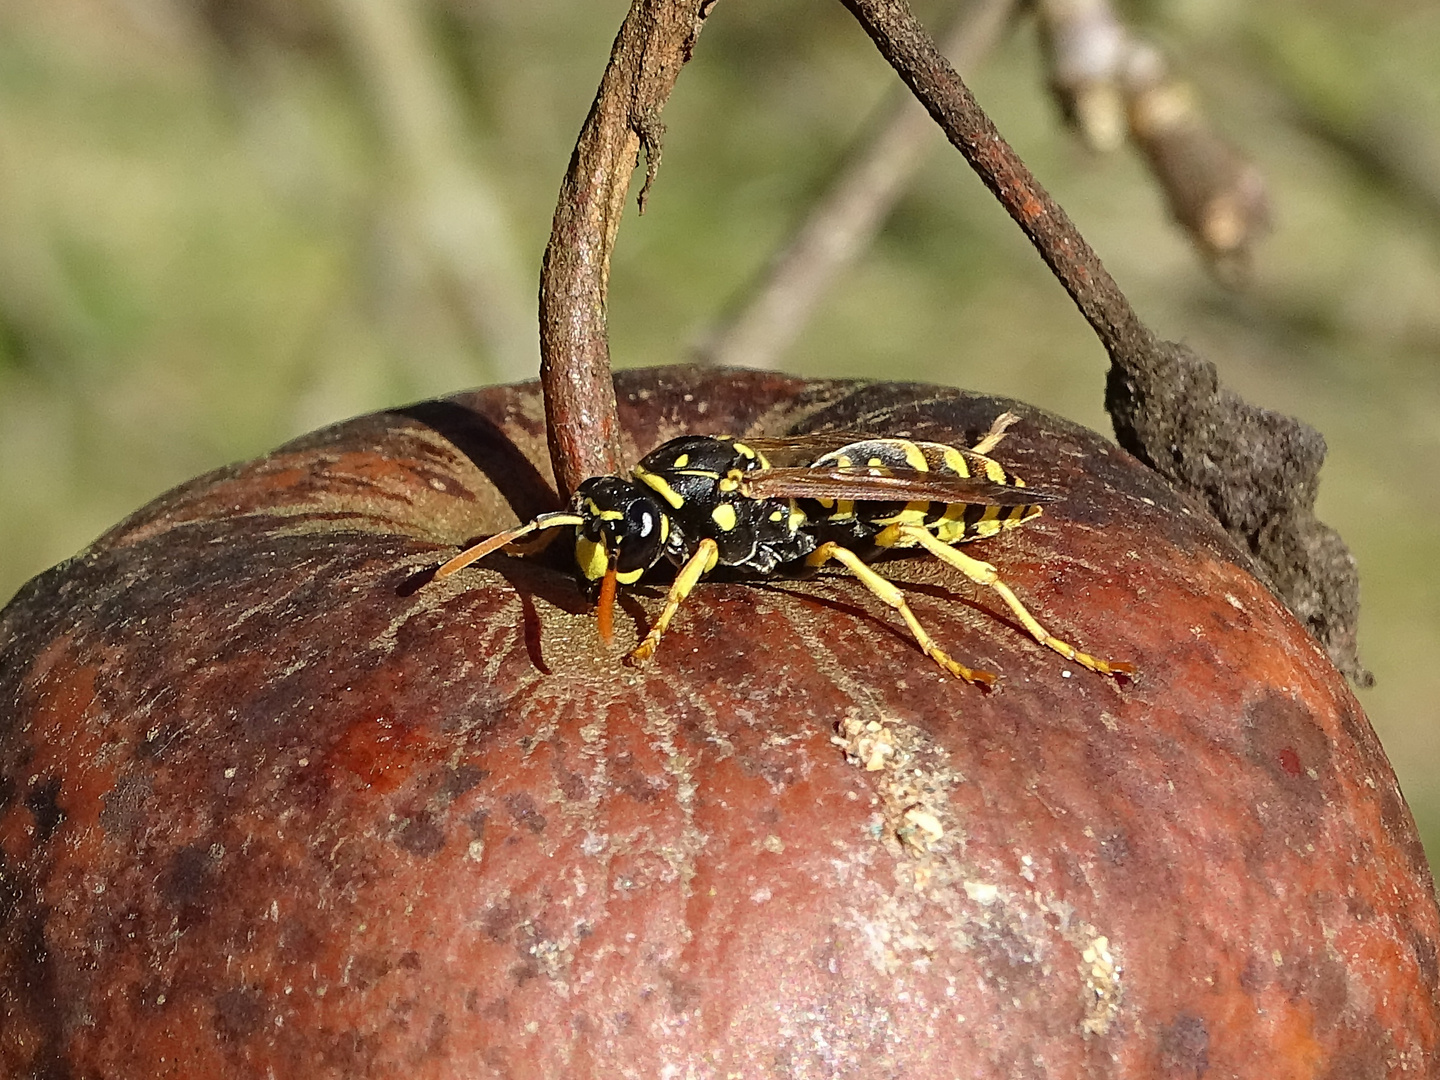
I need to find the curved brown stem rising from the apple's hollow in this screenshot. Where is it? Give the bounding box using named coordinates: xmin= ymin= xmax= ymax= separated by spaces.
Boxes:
xmin=540 ymin=0 xmax=714 ymax=495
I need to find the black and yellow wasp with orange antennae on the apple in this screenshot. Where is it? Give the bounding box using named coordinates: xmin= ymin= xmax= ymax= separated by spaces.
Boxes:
xmin=435 ymin=413 xmax=1135 ymax=687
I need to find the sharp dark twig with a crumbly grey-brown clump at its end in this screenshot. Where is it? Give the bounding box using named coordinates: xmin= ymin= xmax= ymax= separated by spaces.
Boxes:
xmin=842 ymin=0 xmax=1369 ymax=684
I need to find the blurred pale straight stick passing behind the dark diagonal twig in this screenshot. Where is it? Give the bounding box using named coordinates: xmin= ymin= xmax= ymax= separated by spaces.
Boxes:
xmin=696 ymin=0 xmax=1017 ymax=369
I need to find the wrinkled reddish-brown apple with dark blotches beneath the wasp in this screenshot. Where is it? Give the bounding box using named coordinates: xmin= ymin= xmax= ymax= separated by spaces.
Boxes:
xmin=0 ymin=369 xmax=1440 ymax=1080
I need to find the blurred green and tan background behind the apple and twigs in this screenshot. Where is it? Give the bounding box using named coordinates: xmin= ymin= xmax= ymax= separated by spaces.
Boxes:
xmin=0 ymin=0 xmax=1440 ymax=854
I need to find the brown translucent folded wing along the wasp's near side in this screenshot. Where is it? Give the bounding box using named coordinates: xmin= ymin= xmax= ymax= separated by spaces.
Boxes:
xmin=740 ymin=467 xmax=1057 ymax=507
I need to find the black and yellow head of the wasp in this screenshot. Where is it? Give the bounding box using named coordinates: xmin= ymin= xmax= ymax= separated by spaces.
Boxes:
xmin=575 ymin=477 xmax=671 ymax=585
